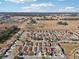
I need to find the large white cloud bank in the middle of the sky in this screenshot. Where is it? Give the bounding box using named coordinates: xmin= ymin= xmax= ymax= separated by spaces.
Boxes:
xmin=21 ymin=3 xmax=54 ymax=12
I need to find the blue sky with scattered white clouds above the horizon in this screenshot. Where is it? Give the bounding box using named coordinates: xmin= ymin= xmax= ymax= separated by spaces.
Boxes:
xmin=0 ymin=0 xmax=79 ymax=12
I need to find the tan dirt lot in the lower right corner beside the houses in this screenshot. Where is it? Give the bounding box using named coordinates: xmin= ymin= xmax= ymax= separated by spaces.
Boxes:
xmin=61 ymin=43 xmax=79 ymax=59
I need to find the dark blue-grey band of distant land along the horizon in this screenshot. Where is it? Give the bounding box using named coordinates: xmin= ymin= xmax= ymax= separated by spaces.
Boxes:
xmin=0 ymin=12 xmax=79 ymax=16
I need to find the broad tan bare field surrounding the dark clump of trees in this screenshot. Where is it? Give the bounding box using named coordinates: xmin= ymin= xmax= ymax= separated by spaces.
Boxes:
xmin=39 ymin=20 xmax=79 ymax=30
